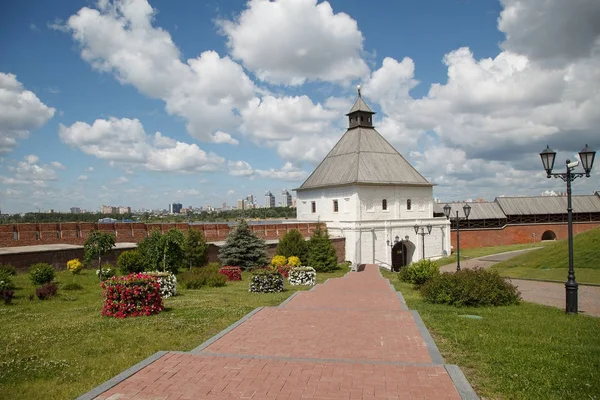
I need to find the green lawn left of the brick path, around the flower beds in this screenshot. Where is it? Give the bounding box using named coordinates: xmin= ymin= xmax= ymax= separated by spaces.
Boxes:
xmin=0 ymin=269 xmax=348 ymax=399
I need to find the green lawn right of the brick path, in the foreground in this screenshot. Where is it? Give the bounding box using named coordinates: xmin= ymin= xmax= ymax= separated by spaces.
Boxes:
xmin=382 ymin=271 xmax=600 ymax=400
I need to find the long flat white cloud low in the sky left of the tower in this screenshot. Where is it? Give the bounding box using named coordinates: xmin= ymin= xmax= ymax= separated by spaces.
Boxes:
xmin=58 ymin=117 xmax=224 ymax=172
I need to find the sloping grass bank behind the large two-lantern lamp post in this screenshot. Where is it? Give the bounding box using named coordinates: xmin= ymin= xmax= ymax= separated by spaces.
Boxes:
xmin=492 ymin=228 xmax=600 ymax=284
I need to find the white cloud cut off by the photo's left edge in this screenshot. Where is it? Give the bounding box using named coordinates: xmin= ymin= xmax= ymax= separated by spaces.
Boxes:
xmin=0 ymin=72 xmax=56 ymax=154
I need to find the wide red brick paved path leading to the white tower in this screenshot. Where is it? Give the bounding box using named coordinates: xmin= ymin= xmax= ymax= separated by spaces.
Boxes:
xmin=81 ymin=265 xmax=477 ymax=400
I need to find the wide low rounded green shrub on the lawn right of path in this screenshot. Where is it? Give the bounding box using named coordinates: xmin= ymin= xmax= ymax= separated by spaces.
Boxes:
xmin=421 ymin=268 xmax=521 ymax=307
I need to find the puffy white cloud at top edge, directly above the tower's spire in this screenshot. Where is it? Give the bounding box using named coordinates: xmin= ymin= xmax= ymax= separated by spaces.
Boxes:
xmin=218 ymin=0 xmax=369 ymax=85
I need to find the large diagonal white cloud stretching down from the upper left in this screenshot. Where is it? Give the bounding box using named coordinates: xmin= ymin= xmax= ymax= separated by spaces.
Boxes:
xmin=66 ymin=0 xmax=254 ymax=142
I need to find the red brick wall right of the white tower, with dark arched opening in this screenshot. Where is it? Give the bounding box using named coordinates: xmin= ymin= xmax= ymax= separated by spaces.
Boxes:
xmin=451 ymin=222 xmax=600 ymax=250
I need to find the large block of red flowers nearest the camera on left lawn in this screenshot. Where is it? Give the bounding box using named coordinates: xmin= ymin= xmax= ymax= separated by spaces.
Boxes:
xmin=100 ymin=274 xmax=164 ymax=318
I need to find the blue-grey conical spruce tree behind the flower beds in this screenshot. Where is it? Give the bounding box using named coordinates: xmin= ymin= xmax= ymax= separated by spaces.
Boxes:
xmin=219 ymin=220 xmax=268 ymax=270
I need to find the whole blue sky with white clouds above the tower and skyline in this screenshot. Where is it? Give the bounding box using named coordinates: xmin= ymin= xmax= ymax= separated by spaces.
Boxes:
xmin=0 ymin=0 xmax=600 ymax=213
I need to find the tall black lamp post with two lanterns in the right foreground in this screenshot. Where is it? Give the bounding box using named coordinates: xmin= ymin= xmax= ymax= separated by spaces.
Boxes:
xmin=540 ymin=144 xmax=596 ymax=314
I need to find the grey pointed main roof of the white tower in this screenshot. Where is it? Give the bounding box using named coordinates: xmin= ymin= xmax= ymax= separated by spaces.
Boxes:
xmin=296 ymin=127 xmax=433 ymax=190
